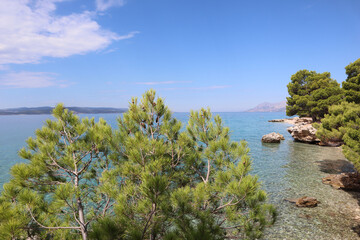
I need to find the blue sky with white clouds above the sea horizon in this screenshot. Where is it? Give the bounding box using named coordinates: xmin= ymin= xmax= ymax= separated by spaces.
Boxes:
xmin=0 ymin=0 xmax=360 ymax=112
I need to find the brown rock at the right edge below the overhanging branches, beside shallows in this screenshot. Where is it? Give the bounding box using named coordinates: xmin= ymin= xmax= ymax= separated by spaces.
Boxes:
xmin=322 ymin=173 xmax=360 ymax=191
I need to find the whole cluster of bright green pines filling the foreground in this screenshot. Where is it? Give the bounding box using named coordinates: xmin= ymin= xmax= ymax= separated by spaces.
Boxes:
xmin=0 ymin=90 xmax=276 ymax=239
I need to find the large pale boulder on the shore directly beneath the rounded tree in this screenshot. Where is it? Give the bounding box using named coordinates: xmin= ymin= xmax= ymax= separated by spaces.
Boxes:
xmin=287 ymin=123 xmax=320 ymax=143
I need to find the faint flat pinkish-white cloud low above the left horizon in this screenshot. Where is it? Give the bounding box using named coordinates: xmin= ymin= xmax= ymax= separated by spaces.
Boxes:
xmin=0 ymin=72 xmax=70 ymax=88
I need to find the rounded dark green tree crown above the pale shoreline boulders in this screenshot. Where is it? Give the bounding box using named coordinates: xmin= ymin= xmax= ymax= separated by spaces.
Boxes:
xmin=286 ymin=70 xmax=342 ymax=121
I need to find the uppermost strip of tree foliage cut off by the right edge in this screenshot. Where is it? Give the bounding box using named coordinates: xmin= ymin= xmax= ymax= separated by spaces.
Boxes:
xmin=342 ymin=58 xmax=360 ymax=104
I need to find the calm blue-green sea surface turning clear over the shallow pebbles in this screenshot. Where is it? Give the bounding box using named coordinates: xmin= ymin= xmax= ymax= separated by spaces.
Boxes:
xmin=0 ymin=113 xmax=359 ymax=239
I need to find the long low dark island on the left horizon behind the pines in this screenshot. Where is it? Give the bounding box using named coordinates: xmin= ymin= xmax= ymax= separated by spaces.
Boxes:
xmin=0 ymin=107 xmax=127 ymax=115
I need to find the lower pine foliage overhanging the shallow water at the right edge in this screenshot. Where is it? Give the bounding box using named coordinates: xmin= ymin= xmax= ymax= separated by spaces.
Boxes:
xmin=316 ymin=102 xmax=360 ymax=171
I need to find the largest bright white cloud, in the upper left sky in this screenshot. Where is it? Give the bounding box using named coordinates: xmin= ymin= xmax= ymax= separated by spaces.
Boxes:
xmin=0 ymin=0 xmax=137 ymax=65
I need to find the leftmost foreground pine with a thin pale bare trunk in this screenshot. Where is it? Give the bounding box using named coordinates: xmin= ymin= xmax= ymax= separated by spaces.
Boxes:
xmin=0 ymin=104 xmax=112 ymax=239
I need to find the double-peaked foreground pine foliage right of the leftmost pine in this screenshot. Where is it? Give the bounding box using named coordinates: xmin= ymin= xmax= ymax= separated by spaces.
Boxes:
xmin=94 ymin=91 xmax=275 ymax=239
